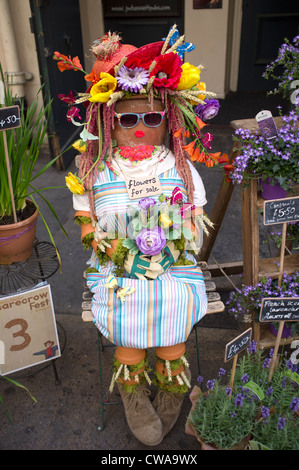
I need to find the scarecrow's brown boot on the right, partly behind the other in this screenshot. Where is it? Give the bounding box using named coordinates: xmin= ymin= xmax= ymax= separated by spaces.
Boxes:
xmin=153 ymin=369 xmax=191 ymax=436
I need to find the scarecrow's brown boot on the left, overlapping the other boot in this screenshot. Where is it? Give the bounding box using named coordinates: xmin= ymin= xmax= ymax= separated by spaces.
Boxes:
xmin=117 ymin=383 xmax=164 ymax=446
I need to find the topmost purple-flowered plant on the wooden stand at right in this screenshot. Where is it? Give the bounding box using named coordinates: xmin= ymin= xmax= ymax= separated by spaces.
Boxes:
xmin=229 ymin=111 xmax=299 ymax=191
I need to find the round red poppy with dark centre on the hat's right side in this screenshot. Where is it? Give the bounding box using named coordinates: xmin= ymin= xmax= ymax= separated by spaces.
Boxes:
xmin=150 ymin=52 xmax=182 ymax=90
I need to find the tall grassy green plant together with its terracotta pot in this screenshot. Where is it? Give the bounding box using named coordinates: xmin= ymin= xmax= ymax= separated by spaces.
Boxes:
xmin=0 ymin=64 xmax=63 ymax=264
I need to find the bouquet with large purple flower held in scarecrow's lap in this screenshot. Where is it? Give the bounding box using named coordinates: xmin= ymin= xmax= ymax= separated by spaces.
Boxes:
xmin=97 ymin=187 xmax=213 ymax=279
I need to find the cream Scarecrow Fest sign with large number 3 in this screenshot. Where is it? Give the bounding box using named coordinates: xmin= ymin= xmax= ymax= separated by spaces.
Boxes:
xmin=0 ymin=285 xmax=61 ymax=375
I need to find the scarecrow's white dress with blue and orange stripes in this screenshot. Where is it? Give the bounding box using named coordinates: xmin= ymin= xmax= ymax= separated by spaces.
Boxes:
xmin=87 ymin=165 xmax=207 ymax=349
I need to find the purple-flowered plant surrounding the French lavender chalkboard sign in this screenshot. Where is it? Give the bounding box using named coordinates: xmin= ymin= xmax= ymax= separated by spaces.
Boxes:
xmin=226 ymin=271 xmax=299 ymax=337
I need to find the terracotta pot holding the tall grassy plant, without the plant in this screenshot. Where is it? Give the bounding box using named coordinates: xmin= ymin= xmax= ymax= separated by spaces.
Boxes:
xmin=0 ymin=201 xmax=38 ymax=265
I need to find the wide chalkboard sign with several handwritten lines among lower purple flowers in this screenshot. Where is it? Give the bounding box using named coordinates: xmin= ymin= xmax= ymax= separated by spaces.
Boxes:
xmin=260 ymin=297 xmax=299 ymax=322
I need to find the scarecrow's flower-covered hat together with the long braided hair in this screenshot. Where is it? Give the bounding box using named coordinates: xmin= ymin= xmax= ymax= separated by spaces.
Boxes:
xmin=54 ymin=25 xmax=228 ymax=210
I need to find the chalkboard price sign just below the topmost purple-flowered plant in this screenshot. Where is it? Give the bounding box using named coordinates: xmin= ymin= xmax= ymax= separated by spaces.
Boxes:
xmin=264 ymin=196 xmax=299 ymax=225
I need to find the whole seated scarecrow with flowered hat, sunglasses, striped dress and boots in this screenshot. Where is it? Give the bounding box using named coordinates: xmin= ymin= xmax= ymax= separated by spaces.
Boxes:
xmin=54 ymin=26 xmax=223 ymax=446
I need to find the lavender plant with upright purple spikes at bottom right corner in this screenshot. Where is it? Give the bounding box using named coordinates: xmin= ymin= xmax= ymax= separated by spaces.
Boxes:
xmin=186 ymin=341 xmax=299 ymax=450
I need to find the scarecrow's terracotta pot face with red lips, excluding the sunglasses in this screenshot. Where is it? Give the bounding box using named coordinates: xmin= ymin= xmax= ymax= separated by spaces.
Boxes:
xmin=111 ymin=98 xmax=167 ymax=147
